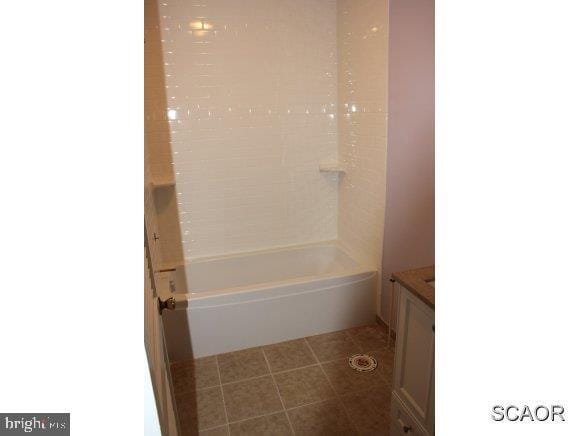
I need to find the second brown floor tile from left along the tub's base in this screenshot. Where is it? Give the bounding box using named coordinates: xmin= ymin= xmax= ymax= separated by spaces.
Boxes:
xmin=217 ymin=348 xmax=269 ymax=383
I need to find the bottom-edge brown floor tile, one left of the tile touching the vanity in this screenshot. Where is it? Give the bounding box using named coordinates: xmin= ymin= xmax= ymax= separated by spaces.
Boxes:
xmin=288 ymin=400 xmax=356 ymax=436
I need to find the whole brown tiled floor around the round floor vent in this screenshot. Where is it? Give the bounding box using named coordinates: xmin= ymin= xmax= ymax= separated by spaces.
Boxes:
xmin=171 ymin=325 xmax=394 ymax=435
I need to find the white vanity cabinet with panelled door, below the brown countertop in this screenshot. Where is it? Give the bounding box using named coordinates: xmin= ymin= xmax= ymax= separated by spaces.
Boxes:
xmin=391 ymin=283 xmax=435 ymax=436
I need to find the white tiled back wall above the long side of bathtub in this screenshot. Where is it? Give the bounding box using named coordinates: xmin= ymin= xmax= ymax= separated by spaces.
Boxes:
xmin=159 ymin=0 xmax=342 ymax=258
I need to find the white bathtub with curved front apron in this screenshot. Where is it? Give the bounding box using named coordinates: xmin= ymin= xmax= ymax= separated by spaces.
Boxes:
xmin=163 ymin=242 xmax=377 ymax=361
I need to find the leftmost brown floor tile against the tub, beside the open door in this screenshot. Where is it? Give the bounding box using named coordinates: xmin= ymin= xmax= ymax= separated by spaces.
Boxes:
xmin=171 ymin=356 xmax=219 ymax=395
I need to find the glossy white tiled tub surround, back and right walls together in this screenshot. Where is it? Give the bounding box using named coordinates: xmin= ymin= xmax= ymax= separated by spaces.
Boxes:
xmin=149 ymin=0 xmax=386 ymax=267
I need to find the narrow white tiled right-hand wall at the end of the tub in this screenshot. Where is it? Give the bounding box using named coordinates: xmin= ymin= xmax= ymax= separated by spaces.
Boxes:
xmin=338 ymin=0 xmax=387 ymax=271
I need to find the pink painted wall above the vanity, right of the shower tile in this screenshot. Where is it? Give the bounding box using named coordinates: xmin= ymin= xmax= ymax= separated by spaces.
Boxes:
xmin=381 ymin=0 xmax=435 ymax=320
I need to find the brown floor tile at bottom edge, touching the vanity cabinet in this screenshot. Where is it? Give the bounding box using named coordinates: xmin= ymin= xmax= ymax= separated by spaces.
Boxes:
xmin=342 ymin=387 xmax=390 ymax=435
